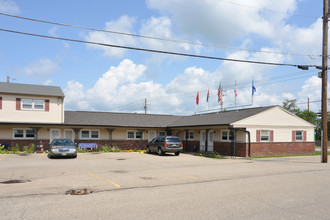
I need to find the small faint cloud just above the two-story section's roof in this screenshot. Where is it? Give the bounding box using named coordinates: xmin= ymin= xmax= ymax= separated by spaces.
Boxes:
xmin=19 ymin=58 xmax=59 ymax=78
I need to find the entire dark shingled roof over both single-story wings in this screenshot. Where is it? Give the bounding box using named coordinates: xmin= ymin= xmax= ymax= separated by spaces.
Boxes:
xmin=64 ymin=106 xmax=274 ymax=128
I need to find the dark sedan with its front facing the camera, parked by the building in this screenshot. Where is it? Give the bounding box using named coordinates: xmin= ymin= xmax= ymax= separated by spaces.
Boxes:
xmin=49 ymin=139 xmax=77 ymax=158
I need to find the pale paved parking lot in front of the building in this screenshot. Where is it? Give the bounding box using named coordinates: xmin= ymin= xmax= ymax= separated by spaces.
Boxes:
xmin=0 ymin=153 xmax=330 ymax=219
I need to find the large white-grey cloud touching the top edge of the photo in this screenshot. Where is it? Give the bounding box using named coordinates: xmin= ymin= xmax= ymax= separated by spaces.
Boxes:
xmin=147 ymin=0 xmax=295 ymax=44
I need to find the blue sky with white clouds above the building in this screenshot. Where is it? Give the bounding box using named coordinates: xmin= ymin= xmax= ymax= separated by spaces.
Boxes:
xmin=0 ymin=0 xmax=323 ymax=115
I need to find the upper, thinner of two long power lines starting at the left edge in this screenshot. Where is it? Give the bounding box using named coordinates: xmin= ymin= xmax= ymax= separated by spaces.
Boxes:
xmin=0 ymin=12 xmax=322 ymax=57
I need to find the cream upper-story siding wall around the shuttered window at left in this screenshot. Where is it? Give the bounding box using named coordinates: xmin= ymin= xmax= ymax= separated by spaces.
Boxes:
xmin=0 ymin=94 xmax=64 ymax=123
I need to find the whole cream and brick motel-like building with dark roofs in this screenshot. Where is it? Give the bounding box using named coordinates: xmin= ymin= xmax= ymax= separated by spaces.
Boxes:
xmin=0 ymin=82 xmax=315 ymax=157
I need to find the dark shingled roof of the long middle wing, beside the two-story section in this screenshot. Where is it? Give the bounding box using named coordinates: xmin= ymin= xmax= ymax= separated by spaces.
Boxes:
xmin=64 ymin=111 xmax=182 ymax=128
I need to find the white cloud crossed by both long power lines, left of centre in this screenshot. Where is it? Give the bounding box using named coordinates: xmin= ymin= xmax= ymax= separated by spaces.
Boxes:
xmin=85 ymin=15 xmax=136 ymax=58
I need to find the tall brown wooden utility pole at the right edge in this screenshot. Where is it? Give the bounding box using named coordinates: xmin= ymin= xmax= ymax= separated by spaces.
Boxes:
xmin=321 ymin=0 xmax=329 ymax=163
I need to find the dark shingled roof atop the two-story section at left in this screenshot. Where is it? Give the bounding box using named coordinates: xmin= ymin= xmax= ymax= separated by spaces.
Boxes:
xmin=0 ymin=82 xmax=64 ymax=97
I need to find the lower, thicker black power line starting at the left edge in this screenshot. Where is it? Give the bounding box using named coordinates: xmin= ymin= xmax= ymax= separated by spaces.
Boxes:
xmin=0 ymin=29 xmax=310 ymax=69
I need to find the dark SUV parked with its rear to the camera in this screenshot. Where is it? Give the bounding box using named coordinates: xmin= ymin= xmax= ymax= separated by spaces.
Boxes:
xmin=147 ymin=136 xmax=183 ymax=156
